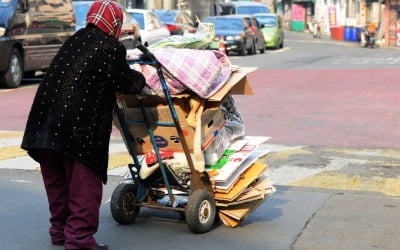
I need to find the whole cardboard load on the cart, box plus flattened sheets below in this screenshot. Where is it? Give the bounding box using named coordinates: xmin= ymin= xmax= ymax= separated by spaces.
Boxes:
xmin=115 ymin=67 xmax=274 ymax=227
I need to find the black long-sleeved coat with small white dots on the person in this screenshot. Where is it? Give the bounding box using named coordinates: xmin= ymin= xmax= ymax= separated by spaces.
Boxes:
xmin=21 ymin=24 xmax=145 ymax=183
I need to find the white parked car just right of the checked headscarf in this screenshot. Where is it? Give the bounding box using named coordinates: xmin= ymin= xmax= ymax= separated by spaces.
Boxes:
xmin=127 ymin=9 xmax=171 ymax=46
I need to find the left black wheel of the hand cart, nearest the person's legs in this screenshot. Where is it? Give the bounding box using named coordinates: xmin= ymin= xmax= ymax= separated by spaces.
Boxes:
xmin=110 ymin=183 xmax=140 ymax=225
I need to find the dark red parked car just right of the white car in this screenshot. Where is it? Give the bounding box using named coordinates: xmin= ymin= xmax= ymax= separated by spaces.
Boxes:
xmin=153 ymin=10 xmax=197 ymax=35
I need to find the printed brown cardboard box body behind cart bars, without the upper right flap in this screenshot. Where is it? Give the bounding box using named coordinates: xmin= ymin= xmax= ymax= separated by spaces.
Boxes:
xmin=124 ymin=96 xmax=226 ymax=154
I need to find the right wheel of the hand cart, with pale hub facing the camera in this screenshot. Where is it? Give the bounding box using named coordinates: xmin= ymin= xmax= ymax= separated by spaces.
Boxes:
xmin=185 ymin=189 xmax=216 ymax=233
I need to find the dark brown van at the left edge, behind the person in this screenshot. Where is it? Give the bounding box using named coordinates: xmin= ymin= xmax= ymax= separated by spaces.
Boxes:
xmin=0 ymin=0 xmax=75 ymax=88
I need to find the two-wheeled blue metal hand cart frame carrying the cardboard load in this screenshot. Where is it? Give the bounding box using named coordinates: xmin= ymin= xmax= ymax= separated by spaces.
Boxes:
xmin=110 ymin=45 xmax=217 ymax=233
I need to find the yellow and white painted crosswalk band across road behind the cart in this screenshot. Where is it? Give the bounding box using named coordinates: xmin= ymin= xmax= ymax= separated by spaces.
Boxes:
xmin=0 ymin=131 xmax=400 ymax=196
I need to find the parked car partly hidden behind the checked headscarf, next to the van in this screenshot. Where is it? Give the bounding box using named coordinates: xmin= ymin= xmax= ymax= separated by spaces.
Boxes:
xmin=72 ymin=0 xmax=141 ymax=49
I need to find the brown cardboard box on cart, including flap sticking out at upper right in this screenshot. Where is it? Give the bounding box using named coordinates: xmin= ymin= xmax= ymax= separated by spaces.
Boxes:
xmin=114 ymin=67 xmax=256 ymax=154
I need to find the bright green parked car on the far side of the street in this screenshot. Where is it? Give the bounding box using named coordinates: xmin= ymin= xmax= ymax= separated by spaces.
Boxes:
xmin=253 ymin=13 xmax=285 ymax=49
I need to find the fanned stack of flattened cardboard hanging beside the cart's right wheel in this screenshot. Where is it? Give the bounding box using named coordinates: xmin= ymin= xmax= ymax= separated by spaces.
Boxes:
xmin=206 ymin=136 xmax=275 ymax=227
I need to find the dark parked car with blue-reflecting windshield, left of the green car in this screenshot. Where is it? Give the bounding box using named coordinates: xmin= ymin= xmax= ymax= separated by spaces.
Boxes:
xmin=203 ymin=15 xmax=256 ymax=56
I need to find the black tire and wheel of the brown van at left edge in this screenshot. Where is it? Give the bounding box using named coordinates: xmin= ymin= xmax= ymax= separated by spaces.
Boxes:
xmin=0 ymin=48 xmax=24 ymax=88
